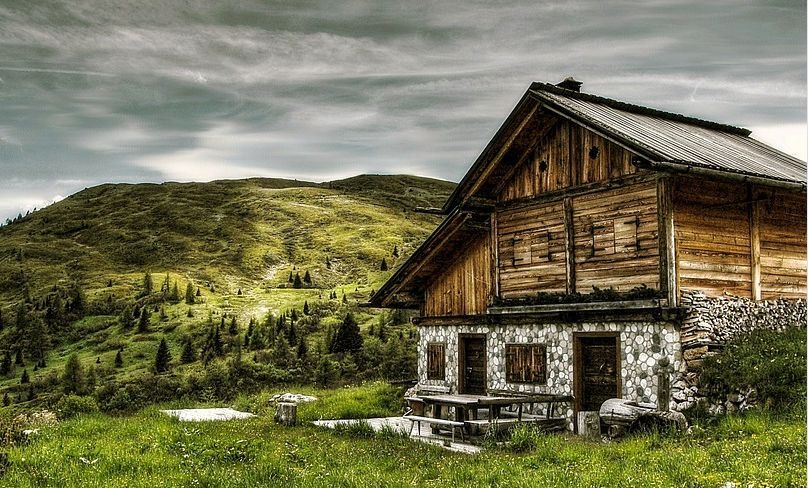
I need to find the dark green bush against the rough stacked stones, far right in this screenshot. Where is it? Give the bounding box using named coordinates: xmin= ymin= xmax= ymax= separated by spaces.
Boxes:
xmin=701 ymin=325 xmax=806 ymax=410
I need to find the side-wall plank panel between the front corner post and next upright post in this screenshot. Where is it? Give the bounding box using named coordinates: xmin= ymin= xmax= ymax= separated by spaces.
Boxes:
xmin=673 ymin=178 xmax=752 ymax=298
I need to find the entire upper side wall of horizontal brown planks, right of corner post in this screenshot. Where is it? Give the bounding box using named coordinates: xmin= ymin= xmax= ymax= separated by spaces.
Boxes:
xmin=673 ymin=178 xmax=808 ymax=300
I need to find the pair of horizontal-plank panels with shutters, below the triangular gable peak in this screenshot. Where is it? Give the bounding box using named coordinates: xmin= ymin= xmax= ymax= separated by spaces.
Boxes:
xmin=497 ymin=181 xmax=660 ymax=299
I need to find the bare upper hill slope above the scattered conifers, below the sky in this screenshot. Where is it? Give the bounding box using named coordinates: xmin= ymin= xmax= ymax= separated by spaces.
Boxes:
xmin=0 ymin=176 xmax=454 ymax=309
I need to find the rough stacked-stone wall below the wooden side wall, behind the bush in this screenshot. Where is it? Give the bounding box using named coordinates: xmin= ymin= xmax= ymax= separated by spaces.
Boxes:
xmin=673 ymin=291 xmax=806 ymax=413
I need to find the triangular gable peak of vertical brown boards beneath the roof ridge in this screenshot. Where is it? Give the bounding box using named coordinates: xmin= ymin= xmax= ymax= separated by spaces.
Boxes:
xmin=499 ymin=119 xmax=636 ymax=202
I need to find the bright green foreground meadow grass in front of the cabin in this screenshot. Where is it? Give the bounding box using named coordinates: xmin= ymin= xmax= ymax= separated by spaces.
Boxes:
xmin=0 ymin=383 xmax=806 ymax=488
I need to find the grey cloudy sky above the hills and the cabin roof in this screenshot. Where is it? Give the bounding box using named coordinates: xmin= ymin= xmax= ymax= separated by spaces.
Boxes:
xmin=0 ymin=0 xmax=806 ymax=221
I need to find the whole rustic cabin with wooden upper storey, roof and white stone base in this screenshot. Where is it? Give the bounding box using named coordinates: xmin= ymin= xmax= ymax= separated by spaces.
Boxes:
xmin=371 ymin=80 xmax=807 ymax=430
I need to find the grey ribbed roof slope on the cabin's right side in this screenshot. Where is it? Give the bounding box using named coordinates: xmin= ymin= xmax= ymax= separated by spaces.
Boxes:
xmin=530 ymin=83 xmax=808 ymax=184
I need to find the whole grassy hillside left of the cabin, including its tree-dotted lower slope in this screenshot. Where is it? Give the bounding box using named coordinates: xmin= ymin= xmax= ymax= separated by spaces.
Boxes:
xmin=0 ymin=176 xmax=454 ymax=412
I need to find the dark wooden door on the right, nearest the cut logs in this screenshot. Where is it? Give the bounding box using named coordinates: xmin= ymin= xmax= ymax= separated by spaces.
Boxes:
xmin=574 ymin=333 xmax=621 ymax=412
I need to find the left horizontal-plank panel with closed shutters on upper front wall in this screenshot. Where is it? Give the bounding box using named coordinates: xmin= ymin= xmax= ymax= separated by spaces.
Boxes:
xmin=497 ymin=202 xmax=567 ymax=298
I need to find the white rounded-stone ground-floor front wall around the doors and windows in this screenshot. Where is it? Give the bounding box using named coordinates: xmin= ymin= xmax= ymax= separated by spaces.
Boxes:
xmin=418 ymin=322 xmax=684 ymax=428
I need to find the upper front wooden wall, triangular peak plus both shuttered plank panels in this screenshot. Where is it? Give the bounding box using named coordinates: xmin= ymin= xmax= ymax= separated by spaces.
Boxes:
xmin=496 ymin=119 xmax=660 ymax=299
